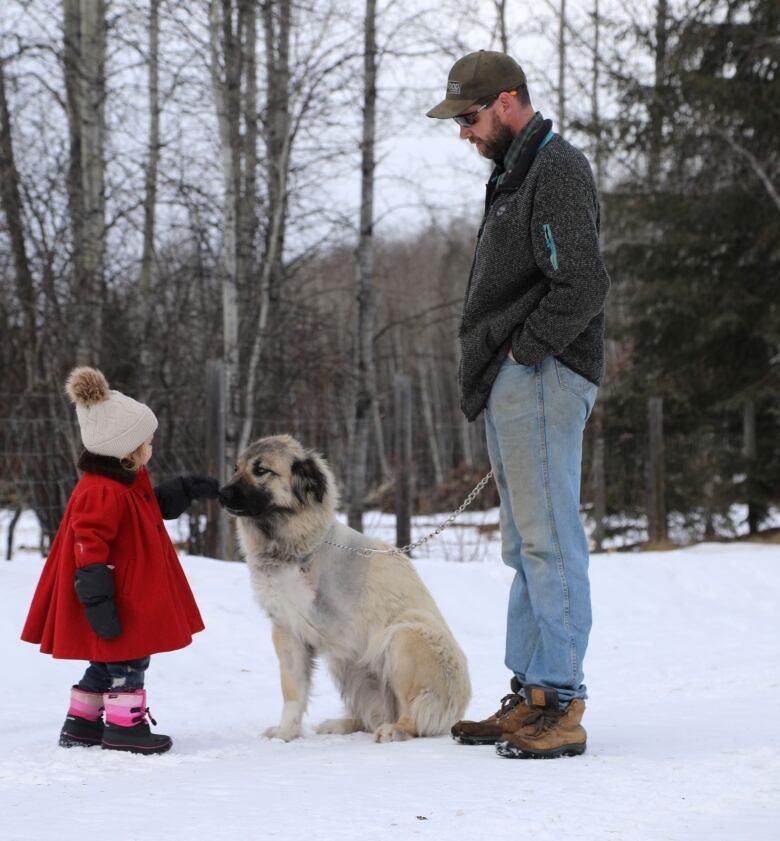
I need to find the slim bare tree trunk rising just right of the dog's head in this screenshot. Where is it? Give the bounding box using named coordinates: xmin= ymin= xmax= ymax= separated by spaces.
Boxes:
xmin=347 ymin=0 xmax=376 ymax=531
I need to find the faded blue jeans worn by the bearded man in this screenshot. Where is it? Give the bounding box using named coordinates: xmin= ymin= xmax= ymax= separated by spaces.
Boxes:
xmin=485 ymin=357 xmax=597 ymax=707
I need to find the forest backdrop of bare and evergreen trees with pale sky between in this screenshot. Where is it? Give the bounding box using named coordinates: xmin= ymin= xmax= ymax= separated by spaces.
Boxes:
xmin=0 ymin=0 xmax=780 ymax=551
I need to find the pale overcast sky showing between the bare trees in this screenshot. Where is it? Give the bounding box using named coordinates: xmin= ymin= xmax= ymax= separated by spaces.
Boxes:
xmin=0 ymin=0 xmax=644 ymax=261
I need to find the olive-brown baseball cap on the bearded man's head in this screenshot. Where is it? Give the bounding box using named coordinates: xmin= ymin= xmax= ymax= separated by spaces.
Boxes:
xmin=426 ymin=50 xmax=525 ymax=120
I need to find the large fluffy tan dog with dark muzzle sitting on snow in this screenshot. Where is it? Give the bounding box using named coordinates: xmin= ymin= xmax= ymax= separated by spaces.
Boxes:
xmin=219 ymin=435 xmax=471 ymax=742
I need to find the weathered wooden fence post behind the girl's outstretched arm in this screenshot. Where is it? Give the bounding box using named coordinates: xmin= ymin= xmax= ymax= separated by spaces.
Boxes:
xmin=205 ymin=359 xmax=228 ymax=559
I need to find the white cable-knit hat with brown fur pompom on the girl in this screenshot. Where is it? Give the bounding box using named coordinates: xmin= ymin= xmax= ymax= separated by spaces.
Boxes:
xmin=65 ymin=368 xmax=157 ymax=458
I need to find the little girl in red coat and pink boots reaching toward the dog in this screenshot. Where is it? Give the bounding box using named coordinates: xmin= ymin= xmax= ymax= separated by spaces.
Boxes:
xmin=22 ymin=368 xmax=218 ymax=753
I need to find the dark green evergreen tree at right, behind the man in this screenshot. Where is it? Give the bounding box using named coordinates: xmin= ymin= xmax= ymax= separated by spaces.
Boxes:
xmin=606 ymin=0 xmax=780 ymax=530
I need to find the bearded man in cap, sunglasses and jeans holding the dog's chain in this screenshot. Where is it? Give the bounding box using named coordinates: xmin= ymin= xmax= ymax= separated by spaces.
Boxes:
xmin=428 ymin=50 xmax=609 ymax=758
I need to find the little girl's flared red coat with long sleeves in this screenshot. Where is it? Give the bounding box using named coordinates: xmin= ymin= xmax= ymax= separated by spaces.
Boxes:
xmin=22 ymin=468 xmax=203 ymax=663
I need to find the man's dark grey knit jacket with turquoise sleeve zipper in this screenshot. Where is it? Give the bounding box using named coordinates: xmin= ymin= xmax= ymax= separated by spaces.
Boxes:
xmin=459 ymin=127 xmax=609 ymax=421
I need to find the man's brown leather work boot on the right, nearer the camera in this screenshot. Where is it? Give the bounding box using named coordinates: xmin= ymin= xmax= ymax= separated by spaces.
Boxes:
xmin=496 ymin=686 xmax=588 ymax=759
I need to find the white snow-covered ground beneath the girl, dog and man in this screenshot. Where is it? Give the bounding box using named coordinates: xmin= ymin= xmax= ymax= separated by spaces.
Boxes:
xmin=0 ymin=508 xmax=780 ymax=841
